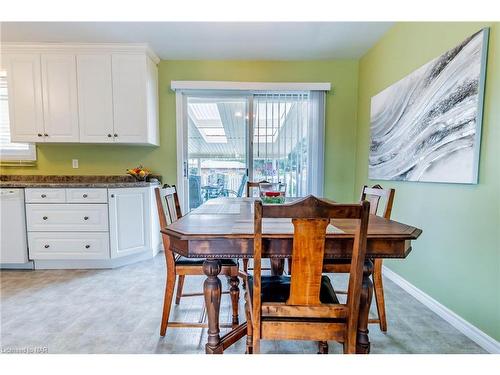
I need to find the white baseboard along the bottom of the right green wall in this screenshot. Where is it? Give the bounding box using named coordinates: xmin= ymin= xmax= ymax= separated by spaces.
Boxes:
xmin=382 ymin=266 xmax=500 ymax=354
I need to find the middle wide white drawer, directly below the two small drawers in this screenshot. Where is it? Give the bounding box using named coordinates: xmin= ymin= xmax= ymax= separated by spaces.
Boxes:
xmin=26 ymin=204 xmax=108 ymax=232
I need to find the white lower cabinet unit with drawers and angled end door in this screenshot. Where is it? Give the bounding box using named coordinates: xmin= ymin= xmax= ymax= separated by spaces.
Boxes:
xmin=26 ymin=187 xmax=159 ymax=268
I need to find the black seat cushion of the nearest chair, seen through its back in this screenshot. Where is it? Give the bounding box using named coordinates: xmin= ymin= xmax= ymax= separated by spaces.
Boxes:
xmin=248 ymin=276 xmax=339 ymax=303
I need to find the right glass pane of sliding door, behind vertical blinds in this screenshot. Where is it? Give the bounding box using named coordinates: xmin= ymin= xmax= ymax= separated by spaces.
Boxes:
xmin=253 ymin=93 xmax=309 ymax=197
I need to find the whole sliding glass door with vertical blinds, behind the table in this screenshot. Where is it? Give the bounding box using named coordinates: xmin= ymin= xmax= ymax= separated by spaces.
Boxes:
xmin=177 ymin=90 xmax=323 ymax=211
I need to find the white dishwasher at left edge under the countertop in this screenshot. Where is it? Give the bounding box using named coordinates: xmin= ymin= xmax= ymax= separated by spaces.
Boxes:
xmin=0 ymin=188 xmax=33 ymax=268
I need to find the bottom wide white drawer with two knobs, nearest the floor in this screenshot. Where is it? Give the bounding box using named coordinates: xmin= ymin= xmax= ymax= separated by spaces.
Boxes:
xmin=28 ymin=232 xmax=109 ymax=260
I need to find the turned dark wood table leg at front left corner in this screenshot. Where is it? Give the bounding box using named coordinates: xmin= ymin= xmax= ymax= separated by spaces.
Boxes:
xmin=203 ymin=259 xmax=223 ymax=354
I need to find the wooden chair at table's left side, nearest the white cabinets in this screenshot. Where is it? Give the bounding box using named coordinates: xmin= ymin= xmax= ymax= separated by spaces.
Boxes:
xmin=155 ymin=185 xmax=240 ymax=336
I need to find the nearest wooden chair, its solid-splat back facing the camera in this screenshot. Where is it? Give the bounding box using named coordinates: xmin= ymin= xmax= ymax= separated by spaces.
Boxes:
xmin=245 ymin=196 xmax=370 ymax=353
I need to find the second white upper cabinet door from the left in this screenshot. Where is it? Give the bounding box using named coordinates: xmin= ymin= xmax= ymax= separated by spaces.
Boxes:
xmin=42 ymin=54 xmax=79 ymax=142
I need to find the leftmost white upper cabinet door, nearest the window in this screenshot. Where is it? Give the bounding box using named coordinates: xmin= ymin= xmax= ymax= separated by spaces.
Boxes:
xmin=2 ymin=53 xmax=44 ymax=142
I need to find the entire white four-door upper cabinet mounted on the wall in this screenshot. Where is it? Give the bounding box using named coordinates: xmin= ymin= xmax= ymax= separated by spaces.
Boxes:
xmin=2 ymin=43 xmax=159 ymax=145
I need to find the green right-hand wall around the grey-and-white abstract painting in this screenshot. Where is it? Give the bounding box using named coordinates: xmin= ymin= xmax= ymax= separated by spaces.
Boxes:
xmin=355 ymin=23 xmax=500 ymax=340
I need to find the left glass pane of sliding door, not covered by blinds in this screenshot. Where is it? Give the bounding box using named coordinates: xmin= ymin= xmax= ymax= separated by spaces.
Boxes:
xmin=187 ymin=96 xmax=248 ymax=210
